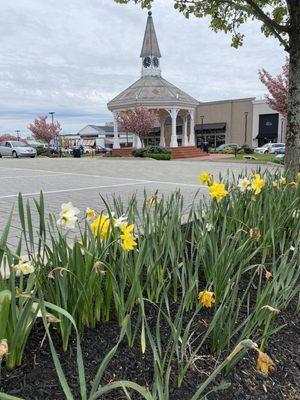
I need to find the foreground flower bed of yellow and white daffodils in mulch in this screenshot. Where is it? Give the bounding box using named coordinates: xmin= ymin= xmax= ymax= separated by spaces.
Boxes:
xmin=0 ymin=172 xmax=300 ymax=400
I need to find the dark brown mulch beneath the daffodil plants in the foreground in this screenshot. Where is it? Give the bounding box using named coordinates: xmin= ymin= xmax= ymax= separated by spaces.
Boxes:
xmin=0 ymin=308 xmax=300 ymax=400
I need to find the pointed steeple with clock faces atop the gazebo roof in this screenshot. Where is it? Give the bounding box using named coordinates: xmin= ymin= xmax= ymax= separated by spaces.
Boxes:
xmin=140 ymin=11 xmax=161 ymax=77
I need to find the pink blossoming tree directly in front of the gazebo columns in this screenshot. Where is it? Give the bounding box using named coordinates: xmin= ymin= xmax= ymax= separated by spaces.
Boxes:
xmin=118 ymin=107 xmax=158 ymax=146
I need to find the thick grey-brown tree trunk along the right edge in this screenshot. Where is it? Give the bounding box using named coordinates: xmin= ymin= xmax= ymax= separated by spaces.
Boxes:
xmin=285 ymin=0 xmax=300 ymax=171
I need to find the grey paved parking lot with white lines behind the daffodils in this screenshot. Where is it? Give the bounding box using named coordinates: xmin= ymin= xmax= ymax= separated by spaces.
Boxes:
xmin=0 ymin=158 xmax=273 ymax=246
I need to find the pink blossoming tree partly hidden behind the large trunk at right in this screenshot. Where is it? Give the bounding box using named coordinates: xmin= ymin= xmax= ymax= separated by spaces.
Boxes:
xmin=259 ymin=59 xmax=289 ymax=117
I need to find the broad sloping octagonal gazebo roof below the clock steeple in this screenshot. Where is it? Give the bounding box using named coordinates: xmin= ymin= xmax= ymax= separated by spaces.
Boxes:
xmin=107 ymin=76 xmax=199 ymax=111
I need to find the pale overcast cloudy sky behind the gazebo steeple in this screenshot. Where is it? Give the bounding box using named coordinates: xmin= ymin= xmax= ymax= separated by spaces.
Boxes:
xmin=0 ymin=0 xmax=285 ymax=135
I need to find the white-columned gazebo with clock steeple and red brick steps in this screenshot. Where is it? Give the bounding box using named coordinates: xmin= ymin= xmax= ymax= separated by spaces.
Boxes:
xmin=107 ymin=11 xmax=203 ymax=158
